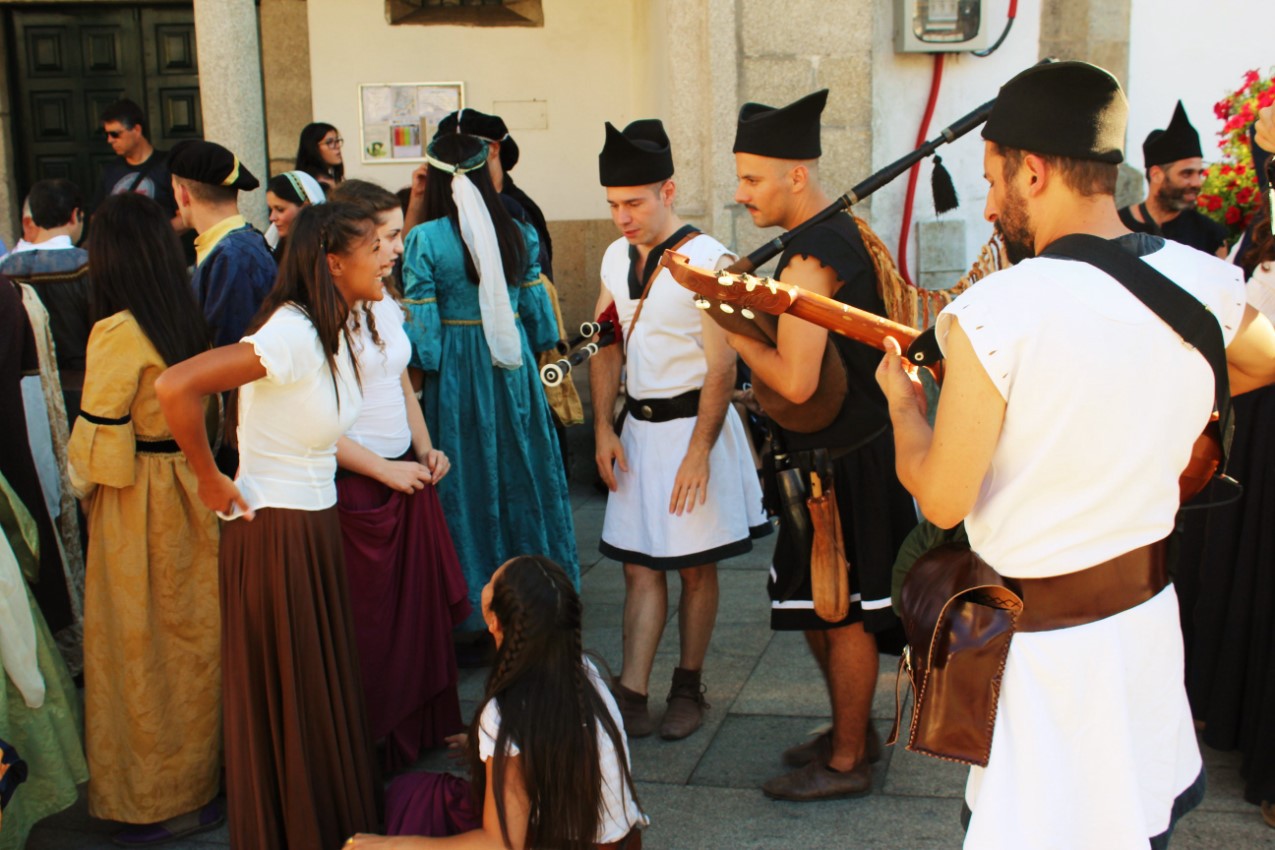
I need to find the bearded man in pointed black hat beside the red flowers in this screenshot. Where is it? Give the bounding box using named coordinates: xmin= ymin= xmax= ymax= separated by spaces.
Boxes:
xmin=1119 ymin=101 xmax=1227 ymax=257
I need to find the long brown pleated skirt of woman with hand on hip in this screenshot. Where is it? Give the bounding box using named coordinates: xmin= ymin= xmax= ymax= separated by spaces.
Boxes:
xmin=221 ymin=507 xmax=380 ymax=850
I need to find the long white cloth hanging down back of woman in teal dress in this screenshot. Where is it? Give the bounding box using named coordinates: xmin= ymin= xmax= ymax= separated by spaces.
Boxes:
xmin=451 ymin=173 xmax=523 ymax=370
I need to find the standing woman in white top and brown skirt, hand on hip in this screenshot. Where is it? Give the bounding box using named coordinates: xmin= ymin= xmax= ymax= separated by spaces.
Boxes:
xmin=156 ymin=204 xmax=393 ymax=850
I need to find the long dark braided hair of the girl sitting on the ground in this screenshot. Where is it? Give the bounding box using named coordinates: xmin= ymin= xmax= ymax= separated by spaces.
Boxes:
xmin=469 ymin=556 xmax=636 ymax=850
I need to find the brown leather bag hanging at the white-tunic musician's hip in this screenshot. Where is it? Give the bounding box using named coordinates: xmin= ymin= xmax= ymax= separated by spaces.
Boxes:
xmin=889 ymin=543 xmax=1023 ymax=767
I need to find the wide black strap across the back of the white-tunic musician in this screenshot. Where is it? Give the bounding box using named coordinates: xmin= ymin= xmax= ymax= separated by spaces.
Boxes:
xmin=1040 ymin=233 xmax=1235 ymax=474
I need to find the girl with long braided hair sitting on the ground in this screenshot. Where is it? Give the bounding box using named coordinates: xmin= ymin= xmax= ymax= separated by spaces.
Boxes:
xmin=351 ymin=556 xmax=649 ymax=850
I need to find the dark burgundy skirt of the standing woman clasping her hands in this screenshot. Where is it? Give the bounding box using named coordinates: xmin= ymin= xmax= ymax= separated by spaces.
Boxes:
xmin=337 ymin=474 xmax=469 ymax=770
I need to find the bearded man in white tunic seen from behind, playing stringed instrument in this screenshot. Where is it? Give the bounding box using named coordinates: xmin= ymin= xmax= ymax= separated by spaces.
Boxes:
xmin=877 ymin=62 xmax=1275 ymax=850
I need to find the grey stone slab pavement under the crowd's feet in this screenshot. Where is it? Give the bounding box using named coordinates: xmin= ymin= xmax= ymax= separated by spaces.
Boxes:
xmin=19 ymin=471 xmax=1275 ymax=850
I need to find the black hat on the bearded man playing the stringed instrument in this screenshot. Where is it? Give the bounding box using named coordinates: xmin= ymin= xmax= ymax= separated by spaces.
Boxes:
xmin=983 ymin=61 xmax=1128 ymax=163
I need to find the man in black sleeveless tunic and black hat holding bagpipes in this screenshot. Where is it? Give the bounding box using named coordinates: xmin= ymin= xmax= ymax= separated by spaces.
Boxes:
xmin=728 ymin=89 xmax=917 ymax=800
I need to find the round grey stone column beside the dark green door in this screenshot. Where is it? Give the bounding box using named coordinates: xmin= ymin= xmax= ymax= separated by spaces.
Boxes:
xmin=195 ymin=0 xmax=270 ymax=229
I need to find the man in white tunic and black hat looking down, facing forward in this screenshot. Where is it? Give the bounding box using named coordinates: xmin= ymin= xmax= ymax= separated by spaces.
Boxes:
xmin=589 ymin=119 xmax=770 ymax=740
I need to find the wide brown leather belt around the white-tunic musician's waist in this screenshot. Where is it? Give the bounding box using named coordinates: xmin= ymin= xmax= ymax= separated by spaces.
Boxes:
xmin=1003 ymin=540 xmax=1169 ymax=632
